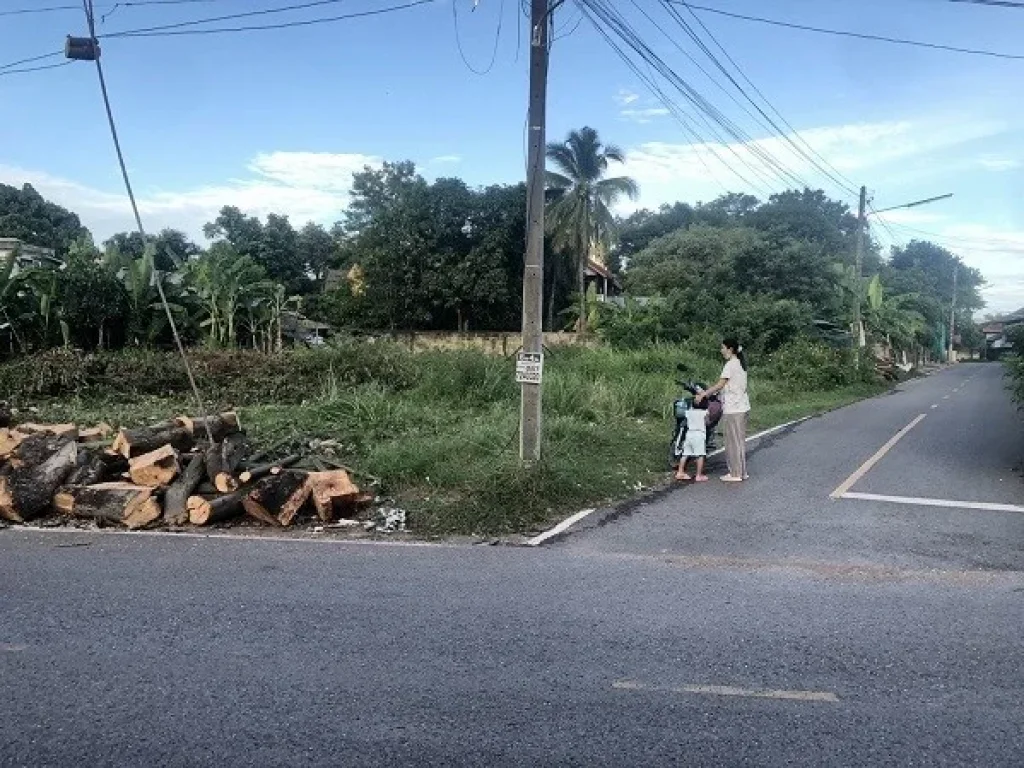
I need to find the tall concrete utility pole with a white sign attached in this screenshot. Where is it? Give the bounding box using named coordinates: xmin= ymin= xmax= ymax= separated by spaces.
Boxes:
xmin=516 ymin=0 xmax=553 ymax=464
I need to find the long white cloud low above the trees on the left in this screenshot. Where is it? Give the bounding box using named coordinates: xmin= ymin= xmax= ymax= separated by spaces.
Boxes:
xmin=0 ymin=152 xmax=381 ymax=242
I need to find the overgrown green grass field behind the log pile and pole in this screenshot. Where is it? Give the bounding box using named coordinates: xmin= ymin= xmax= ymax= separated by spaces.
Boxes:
xmin=8 ymin=345 xmax=882 ymax=536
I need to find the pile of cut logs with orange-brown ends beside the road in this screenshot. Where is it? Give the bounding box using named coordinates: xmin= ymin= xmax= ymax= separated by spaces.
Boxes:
xmin=0 ymin=413 xmax=372 ymax=529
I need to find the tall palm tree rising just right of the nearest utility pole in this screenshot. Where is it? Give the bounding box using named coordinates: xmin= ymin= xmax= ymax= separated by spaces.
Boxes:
xmin=547 ymin=128 xmax=639 ymax=333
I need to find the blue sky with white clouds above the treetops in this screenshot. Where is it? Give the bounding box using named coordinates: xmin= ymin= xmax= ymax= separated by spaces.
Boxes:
xmin=0 ymin=0 xmax=1024 ymax=311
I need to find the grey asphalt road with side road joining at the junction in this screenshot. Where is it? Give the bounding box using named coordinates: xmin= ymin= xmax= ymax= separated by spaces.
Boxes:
xmin=0 ymin=367 xmax=1024 ymax=768
